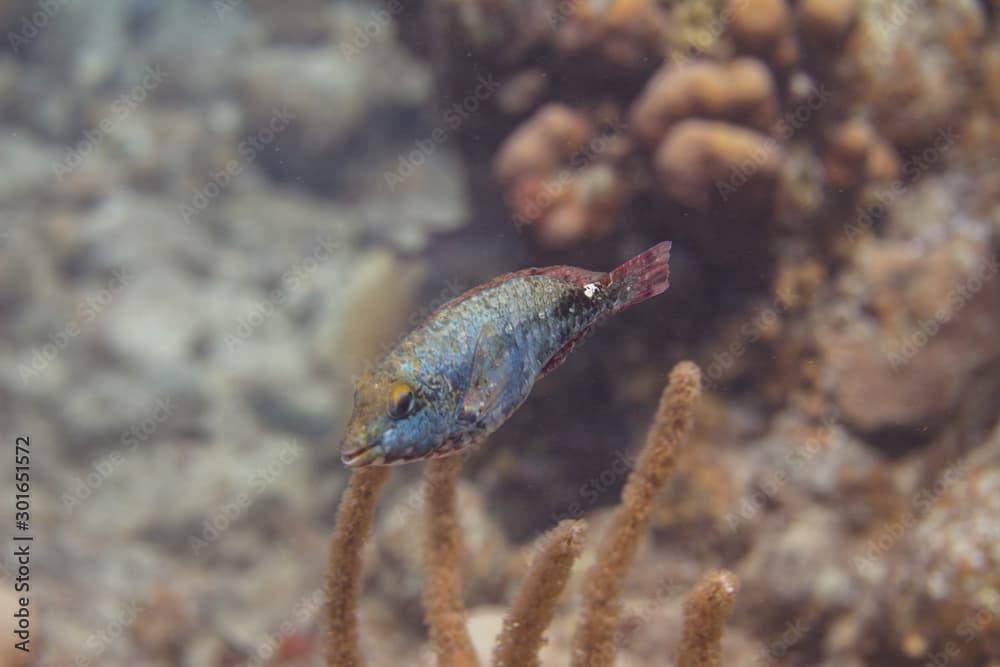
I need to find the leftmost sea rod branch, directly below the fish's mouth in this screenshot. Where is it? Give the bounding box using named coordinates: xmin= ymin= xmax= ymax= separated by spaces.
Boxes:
xmin=325 ymin=467 xmax=389 ymax=667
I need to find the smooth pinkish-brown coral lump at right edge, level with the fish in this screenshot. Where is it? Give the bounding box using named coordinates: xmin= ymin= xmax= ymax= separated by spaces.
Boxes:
xmin=819 ymin=234 xmax=1000 ymax=433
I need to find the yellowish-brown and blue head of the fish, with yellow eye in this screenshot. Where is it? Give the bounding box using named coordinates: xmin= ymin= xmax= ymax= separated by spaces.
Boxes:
xmin=340 ymin=371 xmax=447 ymax=467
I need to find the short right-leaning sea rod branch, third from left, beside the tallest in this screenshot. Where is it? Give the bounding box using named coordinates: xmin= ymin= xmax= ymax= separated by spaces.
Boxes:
xmin=493 ymin=521 xmax=586 ymax=667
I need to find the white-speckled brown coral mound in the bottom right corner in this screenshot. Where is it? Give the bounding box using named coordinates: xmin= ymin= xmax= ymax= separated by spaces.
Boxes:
xmin=884 ymin=428 xmax=1000 ymax=667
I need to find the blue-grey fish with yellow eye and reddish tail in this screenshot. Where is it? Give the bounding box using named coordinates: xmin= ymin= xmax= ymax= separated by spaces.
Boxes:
xmin=340 ymin=241 xmax=671 ymax=467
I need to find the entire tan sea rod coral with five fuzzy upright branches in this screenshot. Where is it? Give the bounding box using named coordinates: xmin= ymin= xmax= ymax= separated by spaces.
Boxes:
xmin=326 ymin=362 xmax=736 ymax=667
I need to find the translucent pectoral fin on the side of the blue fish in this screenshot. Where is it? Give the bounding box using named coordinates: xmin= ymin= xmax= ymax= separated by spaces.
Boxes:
xmin=458 ymin=322 xmax=517 ymax=425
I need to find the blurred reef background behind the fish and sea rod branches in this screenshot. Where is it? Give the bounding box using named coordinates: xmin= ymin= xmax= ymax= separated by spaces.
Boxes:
xmin=0 ymin=0 xmax=1000 ymax=667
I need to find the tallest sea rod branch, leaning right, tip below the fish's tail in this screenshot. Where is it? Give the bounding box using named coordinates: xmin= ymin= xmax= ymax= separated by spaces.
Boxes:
xmin=571 ymin=361 xmax=701 ymax=667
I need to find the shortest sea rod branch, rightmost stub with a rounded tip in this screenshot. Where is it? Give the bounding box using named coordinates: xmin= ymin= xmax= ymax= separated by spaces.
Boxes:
xmin=677 ymin=570 xmax=739 ymax=667
